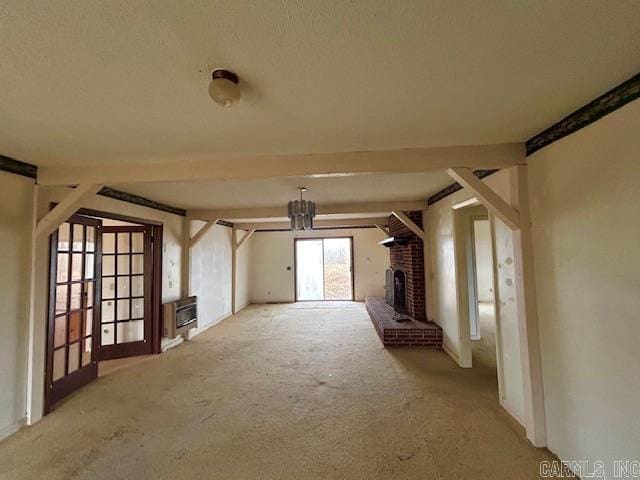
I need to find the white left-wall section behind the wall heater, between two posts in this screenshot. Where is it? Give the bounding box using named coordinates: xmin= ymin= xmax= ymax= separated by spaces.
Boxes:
xmin=190 ymin=221 xmax=234 ymax=334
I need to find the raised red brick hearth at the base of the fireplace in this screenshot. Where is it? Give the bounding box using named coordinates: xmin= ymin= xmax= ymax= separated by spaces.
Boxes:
xmin=365 ymin=298 xmax=442 ymax=349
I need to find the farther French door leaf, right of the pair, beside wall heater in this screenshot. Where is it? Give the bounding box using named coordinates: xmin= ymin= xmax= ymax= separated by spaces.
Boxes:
xmin=99 ymin=226 xmax=151 ymax=360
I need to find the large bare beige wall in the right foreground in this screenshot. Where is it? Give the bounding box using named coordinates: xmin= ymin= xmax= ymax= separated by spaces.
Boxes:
xmin=529 ymin=101 xmax=640 ymax=470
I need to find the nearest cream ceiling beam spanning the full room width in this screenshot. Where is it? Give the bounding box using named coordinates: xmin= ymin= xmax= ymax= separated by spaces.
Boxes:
xmin=38 ymin=143 xmax=525 ymax=185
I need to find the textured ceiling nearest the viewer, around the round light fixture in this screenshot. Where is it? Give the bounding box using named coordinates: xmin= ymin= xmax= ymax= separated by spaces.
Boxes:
xmin=0 ymin=0 xmax=640 ymax=169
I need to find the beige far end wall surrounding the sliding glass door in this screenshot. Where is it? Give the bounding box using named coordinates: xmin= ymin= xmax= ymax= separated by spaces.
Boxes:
xmin=251 ymin=228 xmax=389 ymax=303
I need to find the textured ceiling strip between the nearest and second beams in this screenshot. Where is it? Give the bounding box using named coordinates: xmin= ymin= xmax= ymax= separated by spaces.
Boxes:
xmin=114 ymin=172 xmax=451 ymax=209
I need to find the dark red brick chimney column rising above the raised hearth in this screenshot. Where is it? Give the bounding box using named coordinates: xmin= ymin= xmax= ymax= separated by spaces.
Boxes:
xmin=389 ymin=212 xmax=427 ymax=322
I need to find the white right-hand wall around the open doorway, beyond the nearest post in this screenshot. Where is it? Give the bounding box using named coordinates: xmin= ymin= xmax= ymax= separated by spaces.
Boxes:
xmin=423 ymin=170 xmax=524 ymax=423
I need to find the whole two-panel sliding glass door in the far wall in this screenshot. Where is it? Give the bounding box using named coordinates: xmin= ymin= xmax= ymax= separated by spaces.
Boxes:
xmin=294 ymin=237 xmax=354 ymax=301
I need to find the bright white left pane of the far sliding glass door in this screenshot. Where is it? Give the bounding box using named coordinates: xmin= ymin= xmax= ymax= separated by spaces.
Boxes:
xmin=295 ymin=239 xmax=324 ymax=300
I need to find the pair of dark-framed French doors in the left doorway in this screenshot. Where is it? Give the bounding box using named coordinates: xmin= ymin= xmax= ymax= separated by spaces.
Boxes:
xmin=45 ymin=209 xmax=162 ymax=413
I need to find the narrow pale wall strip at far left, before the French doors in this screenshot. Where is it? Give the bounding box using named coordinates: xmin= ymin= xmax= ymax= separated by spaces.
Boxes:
xmin=0 ymin=172 xmax=34 ymax=439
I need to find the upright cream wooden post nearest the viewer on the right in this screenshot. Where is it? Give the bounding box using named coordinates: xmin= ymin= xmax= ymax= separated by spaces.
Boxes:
xmin=510 ymin=165 xmax=547 ymax=447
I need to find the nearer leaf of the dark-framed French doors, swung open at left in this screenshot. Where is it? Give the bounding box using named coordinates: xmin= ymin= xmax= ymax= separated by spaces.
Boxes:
xmin=45 ymin=215 xmax=101 ymax=411
